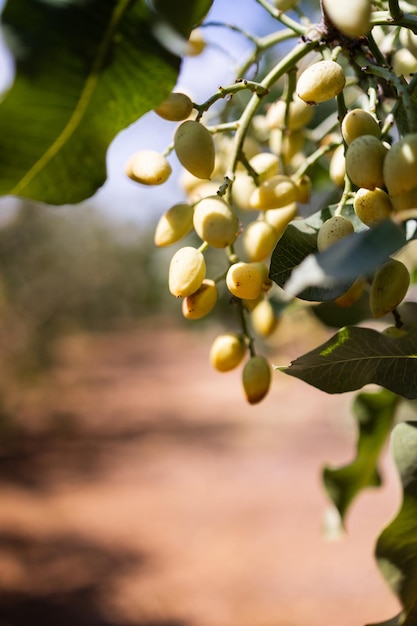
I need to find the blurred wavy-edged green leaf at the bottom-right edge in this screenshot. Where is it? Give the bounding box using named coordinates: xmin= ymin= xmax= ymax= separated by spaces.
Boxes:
xmin=376 ymin=422 xmax=417 ymax=626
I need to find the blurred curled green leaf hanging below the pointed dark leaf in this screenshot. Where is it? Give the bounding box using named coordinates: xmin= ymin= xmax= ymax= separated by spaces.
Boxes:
xmin=323 ymin=389 xmax=399 ymax=521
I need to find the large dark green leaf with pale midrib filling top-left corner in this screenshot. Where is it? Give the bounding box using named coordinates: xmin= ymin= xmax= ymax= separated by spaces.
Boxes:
xmin=0 ymin=0 xmax=211 ymax=204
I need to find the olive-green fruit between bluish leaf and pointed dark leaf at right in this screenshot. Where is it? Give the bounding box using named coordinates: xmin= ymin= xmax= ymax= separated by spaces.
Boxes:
xmin=369 ymin=259 xmax=410 ymax=319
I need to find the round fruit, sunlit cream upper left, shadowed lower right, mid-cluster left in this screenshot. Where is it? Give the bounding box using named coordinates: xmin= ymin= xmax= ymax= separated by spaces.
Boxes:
xmin=193 ymin=196 xmax=239 ymax=248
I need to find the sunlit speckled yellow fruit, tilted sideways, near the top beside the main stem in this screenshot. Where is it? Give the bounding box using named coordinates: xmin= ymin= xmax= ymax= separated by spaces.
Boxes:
xmin=296 ymin=60 xmax=346 ymax=104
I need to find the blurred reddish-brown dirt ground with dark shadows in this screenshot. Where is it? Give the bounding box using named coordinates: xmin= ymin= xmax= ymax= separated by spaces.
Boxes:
xmin=0 ymin=320 xmax=399 ymax=626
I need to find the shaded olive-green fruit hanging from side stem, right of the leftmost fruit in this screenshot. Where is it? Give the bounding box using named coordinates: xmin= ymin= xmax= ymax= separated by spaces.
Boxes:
xmin=174 ymin=120 xmax=215 ymax=179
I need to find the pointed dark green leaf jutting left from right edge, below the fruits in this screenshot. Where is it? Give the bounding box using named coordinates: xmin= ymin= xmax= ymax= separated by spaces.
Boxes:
xmin=279 ymin=327 xmax=417 ymax=399
